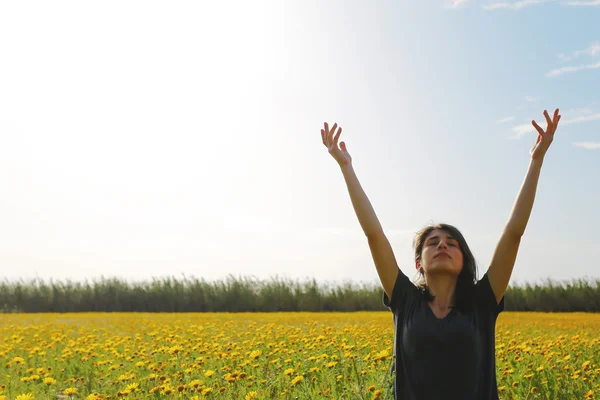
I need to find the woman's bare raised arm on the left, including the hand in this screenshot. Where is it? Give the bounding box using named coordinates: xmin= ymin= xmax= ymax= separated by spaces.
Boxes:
xmin=321 ymin=122 xmax=400 ymax=299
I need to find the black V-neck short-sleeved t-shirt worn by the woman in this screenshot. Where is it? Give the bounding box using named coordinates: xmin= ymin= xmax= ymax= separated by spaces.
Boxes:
xmin=383 ymin=269 xmax=504 ymax=400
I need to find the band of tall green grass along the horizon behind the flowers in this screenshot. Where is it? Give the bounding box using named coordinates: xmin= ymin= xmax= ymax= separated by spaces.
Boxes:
xmin=0 ymin=275 xmax=600 ymax=312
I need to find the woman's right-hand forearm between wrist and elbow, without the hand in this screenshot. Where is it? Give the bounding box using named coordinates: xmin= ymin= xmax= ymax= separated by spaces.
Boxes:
xmin=505 ymin=158 xmax=543 ymax=237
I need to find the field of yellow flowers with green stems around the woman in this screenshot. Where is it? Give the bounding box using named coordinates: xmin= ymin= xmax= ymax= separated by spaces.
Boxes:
xmin=0 ymin=312 xmax=600 ymax=400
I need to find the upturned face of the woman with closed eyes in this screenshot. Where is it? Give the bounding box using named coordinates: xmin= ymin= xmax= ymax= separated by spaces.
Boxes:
xmin=417 ymin=229 xmax=463 ymax=276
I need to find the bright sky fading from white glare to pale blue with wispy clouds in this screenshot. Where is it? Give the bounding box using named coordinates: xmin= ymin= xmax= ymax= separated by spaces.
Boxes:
xmin=0 ymin=0 xmax=600 ymax=284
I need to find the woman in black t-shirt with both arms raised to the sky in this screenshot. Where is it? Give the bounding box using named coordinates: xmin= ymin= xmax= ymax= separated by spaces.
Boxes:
xmin=321 ymin=109 xmax=560 ymax=400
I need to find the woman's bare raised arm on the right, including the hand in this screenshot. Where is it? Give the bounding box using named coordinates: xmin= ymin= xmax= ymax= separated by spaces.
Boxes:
xmin=488 ymin=109 xmax=560 ymax=303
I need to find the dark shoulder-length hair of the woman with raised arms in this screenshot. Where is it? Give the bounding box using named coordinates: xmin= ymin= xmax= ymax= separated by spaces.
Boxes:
xmin=413 ymin=223 xmax=477 ymax=311
